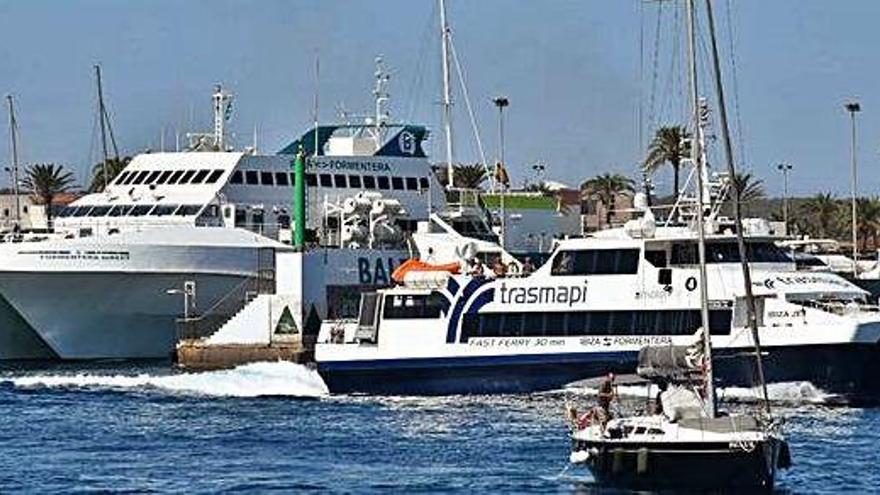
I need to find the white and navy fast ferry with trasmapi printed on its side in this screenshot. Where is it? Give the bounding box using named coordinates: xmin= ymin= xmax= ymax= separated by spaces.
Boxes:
xmin=315 ymin=194 xmax=880 ymax=396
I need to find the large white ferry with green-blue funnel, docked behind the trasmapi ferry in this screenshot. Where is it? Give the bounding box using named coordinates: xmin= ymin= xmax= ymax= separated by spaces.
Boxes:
xmin=0 ymin=78 xmax=464 ymax=359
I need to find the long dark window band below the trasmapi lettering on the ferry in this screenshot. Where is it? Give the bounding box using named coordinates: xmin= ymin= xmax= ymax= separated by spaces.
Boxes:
xmin=462 ymin=309 xmax=733 ymax=341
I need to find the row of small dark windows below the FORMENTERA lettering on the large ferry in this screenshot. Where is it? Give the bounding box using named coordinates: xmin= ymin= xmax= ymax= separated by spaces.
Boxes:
xmin=229 ymin=170 xmax=428 ymax=191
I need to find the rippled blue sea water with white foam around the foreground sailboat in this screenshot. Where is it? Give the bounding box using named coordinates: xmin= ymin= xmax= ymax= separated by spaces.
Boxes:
xmin=0 ymin=363 xmax=880 ymax=493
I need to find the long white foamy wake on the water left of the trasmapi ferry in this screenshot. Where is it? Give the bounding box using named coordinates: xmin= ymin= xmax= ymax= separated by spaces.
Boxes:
xmin=4 ymin=361 xmax=329 ymax=397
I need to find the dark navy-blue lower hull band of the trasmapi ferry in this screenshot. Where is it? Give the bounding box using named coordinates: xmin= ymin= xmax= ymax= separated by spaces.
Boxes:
xmin=318 ymin=344 xmax=880 ymax=401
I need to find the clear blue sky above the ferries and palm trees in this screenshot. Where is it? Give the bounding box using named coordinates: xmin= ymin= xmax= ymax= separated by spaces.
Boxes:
xmin=0 ymin=0 xmax=880 ymax=196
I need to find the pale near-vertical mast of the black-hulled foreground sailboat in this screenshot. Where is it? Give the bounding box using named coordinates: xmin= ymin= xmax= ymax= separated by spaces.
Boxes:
xmin=685 ymin=0 xmax=715 ymax=418
